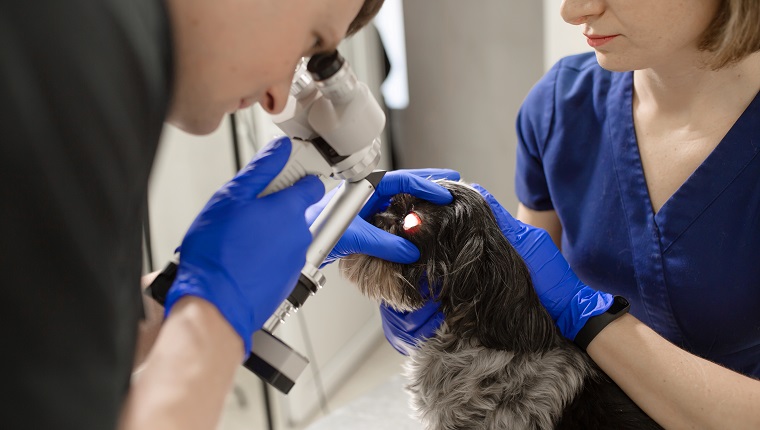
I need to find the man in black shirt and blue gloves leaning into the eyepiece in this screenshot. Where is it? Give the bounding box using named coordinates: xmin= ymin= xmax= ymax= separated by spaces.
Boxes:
xmin=0 ymin=0 xmax=460 ymax=430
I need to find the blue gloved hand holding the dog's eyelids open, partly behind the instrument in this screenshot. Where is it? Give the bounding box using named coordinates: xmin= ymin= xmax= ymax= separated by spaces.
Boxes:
xmin=306 ymin=169 xmax=459 ymax=264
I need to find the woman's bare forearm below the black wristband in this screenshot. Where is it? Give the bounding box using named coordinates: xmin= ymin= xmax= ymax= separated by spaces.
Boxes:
xmin=587 ymin=315 xmax=760 ymax=429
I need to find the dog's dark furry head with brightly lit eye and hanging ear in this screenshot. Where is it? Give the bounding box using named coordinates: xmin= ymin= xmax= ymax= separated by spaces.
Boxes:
xmin=340 ymin=180 xmax=553 ymax=350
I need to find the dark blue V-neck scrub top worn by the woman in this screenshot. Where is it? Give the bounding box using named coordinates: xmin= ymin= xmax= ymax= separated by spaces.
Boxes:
xmin=516 ymin=53 xmax=760 ymax=377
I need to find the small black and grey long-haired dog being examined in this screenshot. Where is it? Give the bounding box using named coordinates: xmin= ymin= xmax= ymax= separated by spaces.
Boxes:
xmin=340 ymin=181 xmax=661 ymax=430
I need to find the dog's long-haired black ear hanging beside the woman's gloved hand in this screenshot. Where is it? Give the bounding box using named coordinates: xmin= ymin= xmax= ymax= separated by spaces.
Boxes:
xmin=439 ymin=190 xmax=556 ymax=352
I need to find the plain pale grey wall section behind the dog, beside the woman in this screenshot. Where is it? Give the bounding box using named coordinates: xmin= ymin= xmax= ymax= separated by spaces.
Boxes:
xmin=396 ymin=0 xmax=544 ymax=214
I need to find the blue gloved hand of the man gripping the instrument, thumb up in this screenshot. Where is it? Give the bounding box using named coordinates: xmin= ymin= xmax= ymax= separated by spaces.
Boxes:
xmin=165 ymin=138 xmax=325 ymax=356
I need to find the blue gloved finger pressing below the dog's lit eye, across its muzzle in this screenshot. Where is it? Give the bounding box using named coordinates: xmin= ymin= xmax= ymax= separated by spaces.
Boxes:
xmin=335 ymin=218 xmax=420 ymax=264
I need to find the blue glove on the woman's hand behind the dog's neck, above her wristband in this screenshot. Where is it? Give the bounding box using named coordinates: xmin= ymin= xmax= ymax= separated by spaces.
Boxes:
xmin=474 ymin=184 xmax=613 ymax=340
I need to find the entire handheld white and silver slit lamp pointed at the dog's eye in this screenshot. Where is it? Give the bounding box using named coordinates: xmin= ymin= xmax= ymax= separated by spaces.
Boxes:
xmin=244 ymin=51 xmax=385 ymax=394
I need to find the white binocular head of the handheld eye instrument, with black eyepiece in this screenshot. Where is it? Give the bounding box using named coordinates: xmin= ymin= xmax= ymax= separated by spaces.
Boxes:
xmin=261 ymin=51 xmax=385 ymax=196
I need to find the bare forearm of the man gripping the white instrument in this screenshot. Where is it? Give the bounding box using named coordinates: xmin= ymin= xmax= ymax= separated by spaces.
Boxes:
xmin=120 ymin=297 xmax=243 ymax=430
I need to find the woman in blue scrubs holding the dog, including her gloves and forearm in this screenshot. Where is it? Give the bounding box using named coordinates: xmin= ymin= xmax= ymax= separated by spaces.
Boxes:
xmin=381 ymin=0 xmax=760 ymax=429
